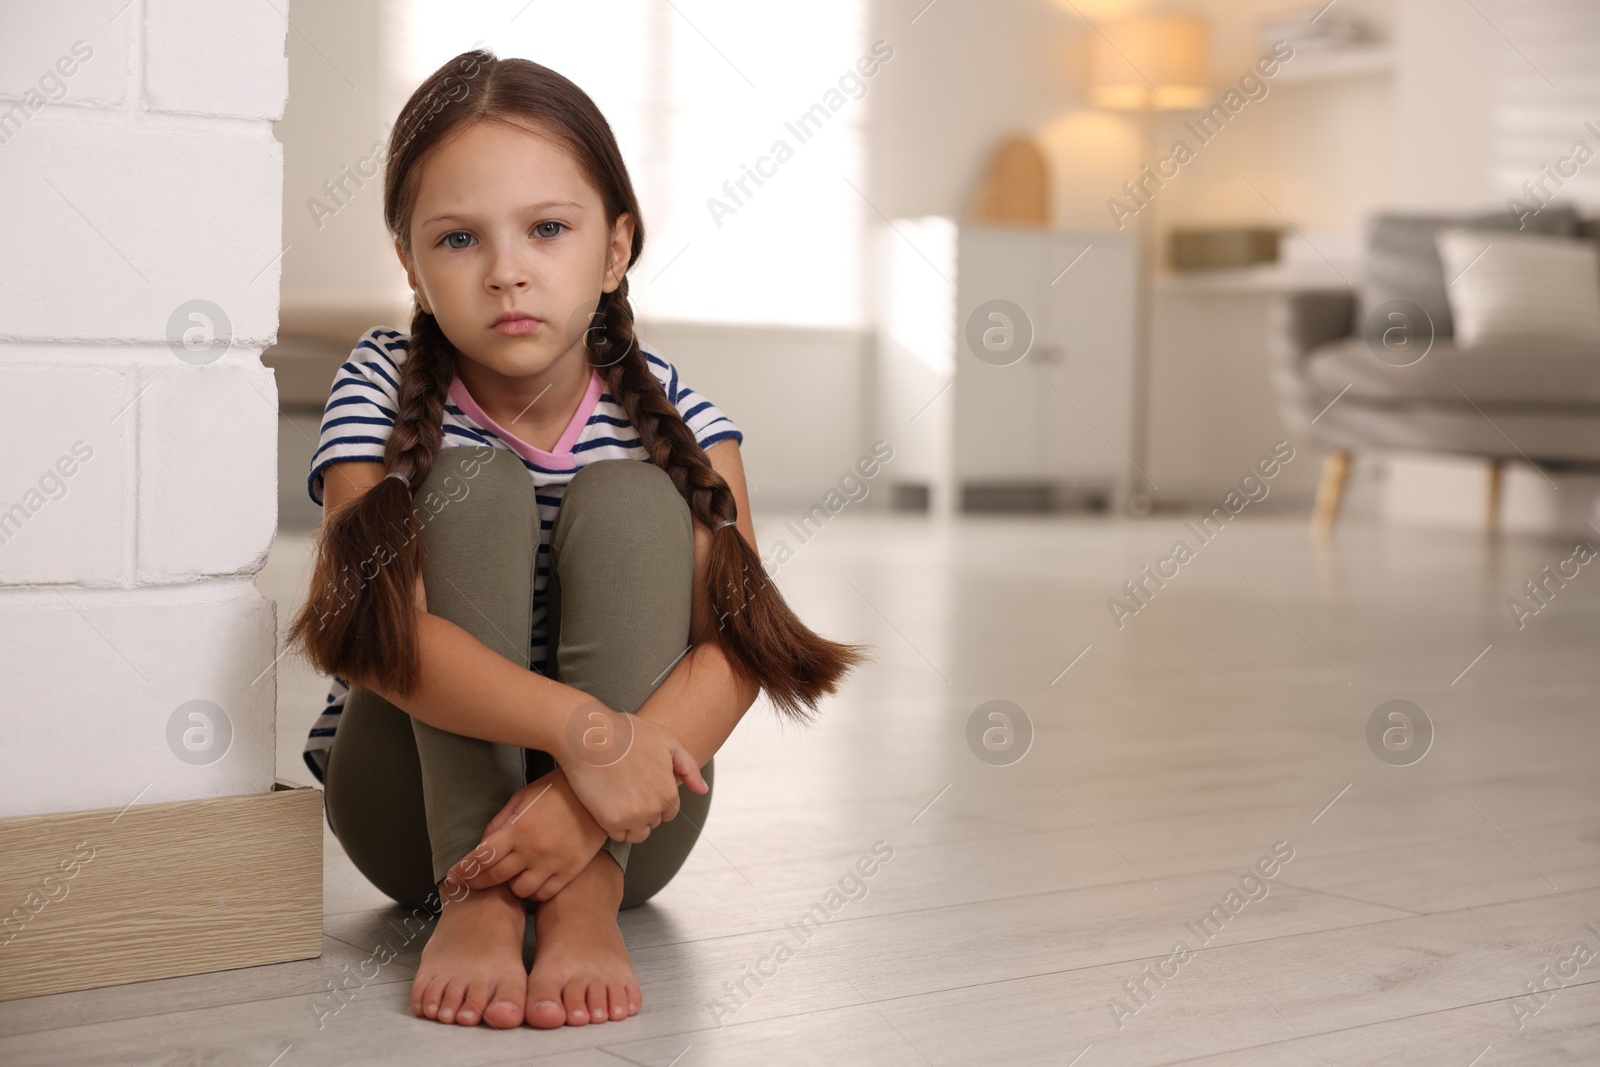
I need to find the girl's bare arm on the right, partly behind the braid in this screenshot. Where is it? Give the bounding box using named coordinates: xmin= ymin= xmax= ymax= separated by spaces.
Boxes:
xmin=638 ymin=440 xmax=771 ymax=766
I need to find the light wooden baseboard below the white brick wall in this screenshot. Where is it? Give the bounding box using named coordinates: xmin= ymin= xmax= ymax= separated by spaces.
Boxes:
xmin=0 ymin=781 xmax=322 ymax=1000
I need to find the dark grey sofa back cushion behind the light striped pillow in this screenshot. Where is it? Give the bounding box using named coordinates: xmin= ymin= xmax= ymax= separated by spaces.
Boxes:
xmin=1355 ymin=206 xmax=1579 ymax=338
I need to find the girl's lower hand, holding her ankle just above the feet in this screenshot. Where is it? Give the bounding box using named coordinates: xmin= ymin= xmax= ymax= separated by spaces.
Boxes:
xmin=446 ymin=768 xmax=606 ymax=901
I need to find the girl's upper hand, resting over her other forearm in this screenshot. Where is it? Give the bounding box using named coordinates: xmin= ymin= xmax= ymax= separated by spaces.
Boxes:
xmin=560 ymin=701 xmax=710 ymax=845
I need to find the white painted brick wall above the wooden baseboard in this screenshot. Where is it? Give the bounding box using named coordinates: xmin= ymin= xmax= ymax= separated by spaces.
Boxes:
xmin=0 ymin=0 xmax=288 ymax=817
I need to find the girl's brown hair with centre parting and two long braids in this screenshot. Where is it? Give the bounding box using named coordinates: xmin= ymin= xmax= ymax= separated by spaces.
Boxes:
xmin=288 ymin=51 xmax=870 ymax=721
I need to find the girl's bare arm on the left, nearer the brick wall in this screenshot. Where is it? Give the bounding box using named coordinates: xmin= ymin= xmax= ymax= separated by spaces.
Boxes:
xmin=323 ymin=461 xmax=592 ymax=763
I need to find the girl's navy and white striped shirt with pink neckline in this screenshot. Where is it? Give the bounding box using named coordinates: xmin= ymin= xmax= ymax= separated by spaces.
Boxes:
xmin=304 ymin=326 xmax=744 ymax=782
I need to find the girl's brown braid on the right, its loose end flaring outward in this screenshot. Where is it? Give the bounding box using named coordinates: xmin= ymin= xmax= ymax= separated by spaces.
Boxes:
xmin=587 ymin=275 xmax=870 ymax=721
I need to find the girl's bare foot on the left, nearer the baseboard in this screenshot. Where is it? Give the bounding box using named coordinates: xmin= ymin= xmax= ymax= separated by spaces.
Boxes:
xmin=411 ymin=876 xmax=531 ymax=1030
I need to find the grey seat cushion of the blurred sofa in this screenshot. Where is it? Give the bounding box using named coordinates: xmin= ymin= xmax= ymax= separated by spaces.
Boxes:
xmin=1304 ymin=338 xmax=1600 ymax=410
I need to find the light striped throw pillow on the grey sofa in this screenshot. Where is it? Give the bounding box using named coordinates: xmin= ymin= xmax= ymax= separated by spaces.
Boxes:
xmin=1435 ymin=226 xmax=1600 ymax=350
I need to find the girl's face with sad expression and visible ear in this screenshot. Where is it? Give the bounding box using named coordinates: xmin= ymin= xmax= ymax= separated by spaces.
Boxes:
xmin=395 ymin=122 xmax=634 ymax=378
